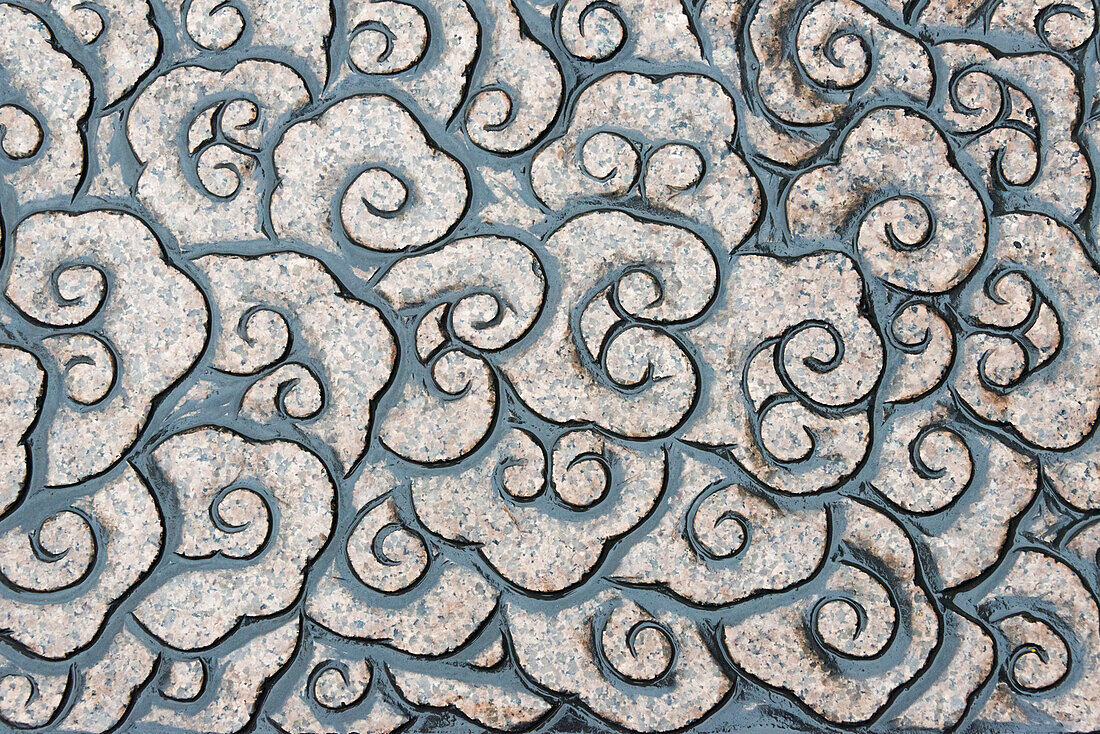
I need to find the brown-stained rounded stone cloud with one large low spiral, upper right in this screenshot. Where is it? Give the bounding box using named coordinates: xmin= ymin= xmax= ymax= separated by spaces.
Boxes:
xmin=787 ymin=108 xmax=987 ymax=293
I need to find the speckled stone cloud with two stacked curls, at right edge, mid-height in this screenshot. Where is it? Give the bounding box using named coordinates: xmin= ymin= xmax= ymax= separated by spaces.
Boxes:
xmin=954 ymin=215 xmax=1100 ymax=449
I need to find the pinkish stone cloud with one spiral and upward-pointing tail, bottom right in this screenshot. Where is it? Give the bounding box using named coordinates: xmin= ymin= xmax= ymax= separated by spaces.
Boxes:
xmin=723 ymin=501 xmax=941 ymax=724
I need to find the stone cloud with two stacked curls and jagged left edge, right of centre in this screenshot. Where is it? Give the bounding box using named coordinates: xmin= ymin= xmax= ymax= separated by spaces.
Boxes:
xmin=684 ymin=253 xmax=883 ymax=494
